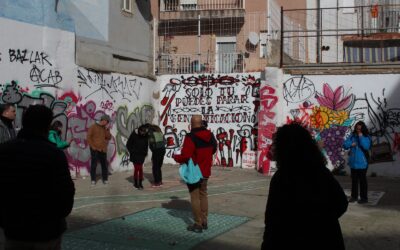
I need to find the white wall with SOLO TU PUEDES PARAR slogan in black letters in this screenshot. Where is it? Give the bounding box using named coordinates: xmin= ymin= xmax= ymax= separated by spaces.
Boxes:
xmin=158 ymin=73 xmax=260 ymax=168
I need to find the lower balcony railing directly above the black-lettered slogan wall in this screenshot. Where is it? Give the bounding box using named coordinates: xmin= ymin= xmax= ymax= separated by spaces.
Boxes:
xmin=157 ymin=52 xmax=244 ymax=74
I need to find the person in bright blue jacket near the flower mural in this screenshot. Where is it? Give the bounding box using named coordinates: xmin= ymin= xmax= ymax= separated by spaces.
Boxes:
xmin=343 ymin=121 xmax=371 ymax=204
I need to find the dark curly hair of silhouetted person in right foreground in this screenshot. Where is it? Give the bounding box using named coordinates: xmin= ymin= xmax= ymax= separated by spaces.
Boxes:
xmin=272 ymin=123 xmax=327 ymax=173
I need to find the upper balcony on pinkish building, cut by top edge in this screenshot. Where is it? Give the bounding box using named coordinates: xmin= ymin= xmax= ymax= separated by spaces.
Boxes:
xmin=160 ymin=0 xmax=245 ymax=20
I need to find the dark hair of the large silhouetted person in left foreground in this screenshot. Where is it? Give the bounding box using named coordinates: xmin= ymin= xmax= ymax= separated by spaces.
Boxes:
xmin=22 ymin=105 xmax=53 ymax=134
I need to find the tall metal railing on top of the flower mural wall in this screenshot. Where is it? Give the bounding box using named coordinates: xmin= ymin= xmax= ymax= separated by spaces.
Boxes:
xmin=280 ymin=4 xmax=400 ymax=67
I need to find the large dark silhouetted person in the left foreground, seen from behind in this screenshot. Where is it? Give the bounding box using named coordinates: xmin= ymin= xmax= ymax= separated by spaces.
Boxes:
xmin=0 ymin=105 xmax=75 ymax=250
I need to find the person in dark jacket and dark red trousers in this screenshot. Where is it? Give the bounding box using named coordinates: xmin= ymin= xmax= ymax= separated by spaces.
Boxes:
xmin=126 ymin=125 xmax=149 ymax=189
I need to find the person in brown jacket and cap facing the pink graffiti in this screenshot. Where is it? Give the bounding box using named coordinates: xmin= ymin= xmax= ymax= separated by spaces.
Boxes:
xmin=86 ymin=114 xmax=111 ymax=186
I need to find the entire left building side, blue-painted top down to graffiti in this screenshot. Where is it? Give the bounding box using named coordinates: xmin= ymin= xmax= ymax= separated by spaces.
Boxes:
xmin=0 ymin=0 xmax=158 ymax=176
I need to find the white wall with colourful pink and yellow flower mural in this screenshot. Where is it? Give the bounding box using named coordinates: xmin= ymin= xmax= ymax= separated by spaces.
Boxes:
xmin=282 ymin=73 xmax=400 ymax=176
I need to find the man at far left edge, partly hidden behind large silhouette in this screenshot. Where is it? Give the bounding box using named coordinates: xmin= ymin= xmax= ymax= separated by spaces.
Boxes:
xmin=0 ymin=103 xmax=17 ymax=143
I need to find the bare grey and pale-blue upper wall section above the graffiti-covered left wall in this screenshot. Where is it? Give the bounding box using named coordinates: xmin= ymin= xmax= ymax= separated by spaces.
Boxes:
xmin=65 ymin=0 xmax=153 ymax=77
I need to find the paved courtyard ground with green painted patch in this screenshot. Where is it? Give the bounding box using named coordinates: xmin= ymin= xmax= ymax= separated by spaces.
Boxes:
xmin=0 ymin=165 xmax=400 ymax=250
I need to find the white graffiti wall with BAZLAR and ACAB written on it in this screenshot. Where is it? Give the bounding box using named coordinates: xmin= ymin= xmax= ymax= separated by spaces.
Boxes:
xmin=0 ymin=18 xmax=159 ymax=176
